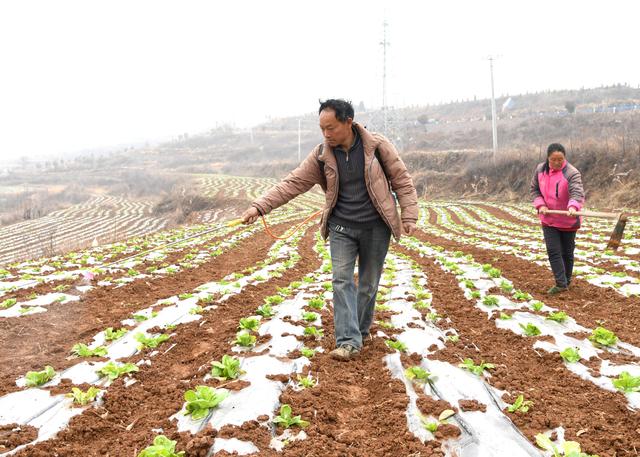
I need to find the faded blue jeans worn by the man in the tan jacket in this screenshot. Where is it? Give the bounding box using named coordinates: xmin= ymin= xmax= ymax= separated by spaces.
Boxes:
xmin=329 ymin=223 xmax=391 ymax=349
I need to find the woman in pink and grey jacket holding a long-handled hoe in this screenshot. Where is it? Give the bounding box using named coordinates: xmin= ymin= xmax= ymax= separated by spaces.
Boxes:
xmin=531 ymin=143 xmax=584 ymax=294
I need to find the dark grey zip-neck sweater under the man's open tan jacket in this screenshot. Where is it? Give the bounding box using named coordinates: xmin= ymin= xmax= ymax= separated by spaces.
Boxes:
xmin=329 ymin=129 xmax=384 ymax=228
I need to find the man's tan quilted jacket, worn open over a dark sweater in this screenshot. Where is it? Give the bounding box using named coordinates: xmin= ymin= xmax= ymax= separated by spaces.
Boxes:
xmin=252 ymin=122 xmax=418 ymax=239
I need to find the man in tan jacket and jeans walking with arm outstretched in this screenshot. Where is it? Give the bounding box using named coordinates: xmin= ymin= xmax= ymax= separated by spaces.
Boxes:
xmin=242 ymin=99 xmax=418 ymax=360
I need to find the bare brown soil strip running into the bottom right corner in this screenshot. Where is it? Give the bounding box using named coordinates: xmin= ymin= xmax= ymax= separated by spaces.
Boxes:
xmin=399 ymin=240 xmax=640 ymax=457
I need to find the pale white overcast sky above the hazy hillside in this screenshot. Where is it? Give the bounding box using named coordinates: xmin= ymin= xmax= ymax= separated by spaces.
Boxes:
xmin=0 ymin=0 xmax=640 ymax=159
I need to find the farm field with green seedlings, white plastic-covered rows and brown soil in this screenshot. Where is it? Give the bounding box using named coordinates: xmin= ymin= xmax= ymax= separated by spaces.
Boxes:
xmin=0 ymin=177 xmax=640 ymax=457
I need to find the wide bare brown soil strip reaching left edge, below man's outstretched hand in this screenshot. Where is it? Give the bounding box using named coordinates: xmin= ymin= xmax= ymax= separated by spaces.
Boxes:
xmin=0 ymin=224 xmax=296 ymax=395
